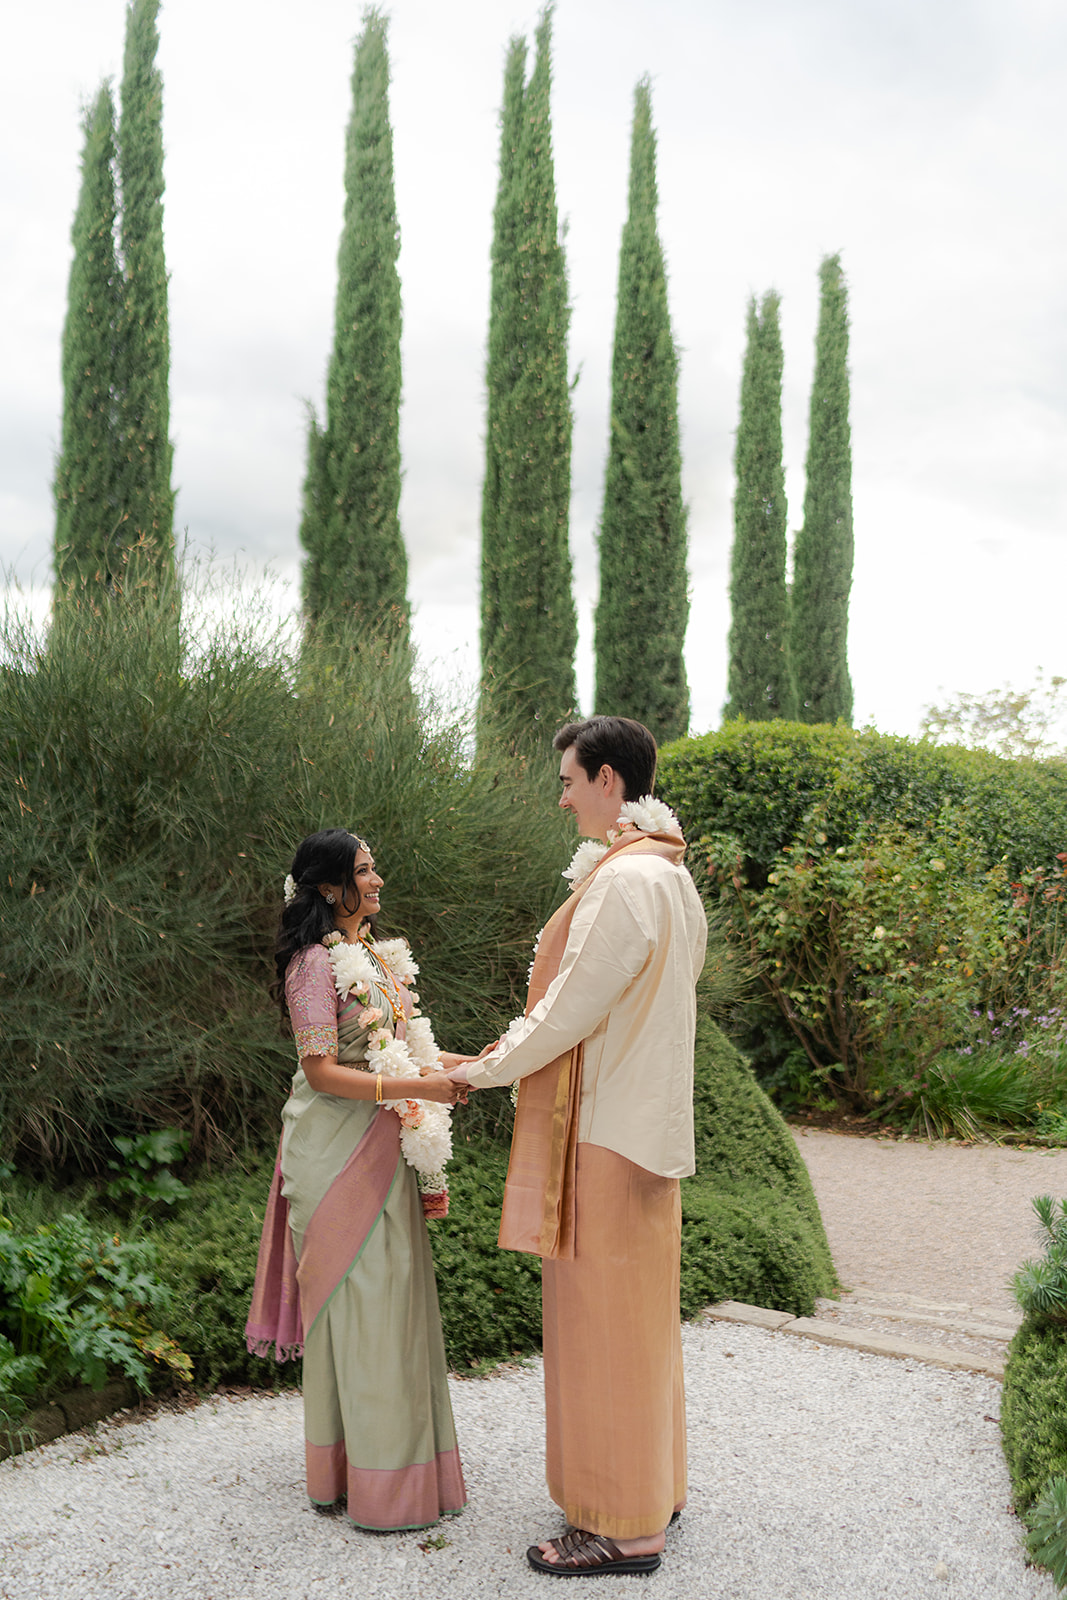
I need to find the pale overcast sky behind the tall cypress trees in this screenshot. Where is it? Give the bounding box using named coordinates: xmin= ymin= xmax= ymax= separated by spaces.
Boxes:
xmin=0 ymin=0 xmax=1067 ymax=733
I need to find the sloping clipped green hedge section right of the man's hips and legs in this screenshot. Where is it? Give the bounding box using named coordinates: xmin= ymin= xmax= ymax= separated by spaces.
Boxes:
xmin=681 ymin=1018 xmax=837 ymax=1317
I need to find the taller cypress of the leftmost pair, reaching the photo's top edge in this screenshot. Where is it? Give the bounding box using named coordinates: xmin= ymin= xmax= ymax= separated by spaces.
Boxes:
xmin=117 ymin=0 xmax=174 ymax=581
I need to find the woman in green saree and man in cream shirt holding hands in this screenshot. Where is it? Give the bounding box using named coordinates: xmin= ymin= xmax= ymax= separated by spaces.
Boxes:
xmin=246 ymin=717 xmax=707 ymax=1578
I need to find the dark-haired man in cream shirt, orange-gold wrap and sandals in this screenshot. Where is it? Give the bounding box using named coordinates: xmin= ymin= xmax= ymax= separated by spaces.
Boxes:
xmin=451 ymin=717 xmax=707 ymax=1574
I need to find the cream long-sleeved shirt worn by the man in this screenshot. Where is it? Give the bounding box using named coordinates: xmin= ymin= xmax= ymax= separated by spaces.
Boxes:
xmin=469 ymin=850 xmax=707 ymax=1178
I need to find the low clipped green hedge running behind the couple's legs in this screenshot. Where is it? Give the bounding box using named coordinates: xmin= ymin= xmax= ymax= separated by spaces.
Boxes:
xmin=155 ymin=1021 xmax=835 ymax=1387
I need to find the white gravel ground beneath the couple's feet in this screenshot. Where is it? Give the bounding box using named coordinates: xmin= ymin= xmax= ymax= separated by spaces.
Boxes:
xmin=0 ymin=1323 xmax=1054 ymax=1600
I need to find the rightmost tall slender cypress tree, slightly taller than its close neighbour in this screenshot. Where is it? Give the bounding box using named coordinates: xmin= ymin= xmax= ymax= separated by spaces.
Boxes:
xmin=790 ymin=256 xmax=853 ymax=722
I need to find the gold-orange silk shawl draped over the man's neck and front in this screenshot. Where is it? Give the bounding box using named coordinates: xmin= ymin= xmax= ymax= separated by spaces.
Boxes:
xmin=499 ymin=834 xmax=685 ymax=1261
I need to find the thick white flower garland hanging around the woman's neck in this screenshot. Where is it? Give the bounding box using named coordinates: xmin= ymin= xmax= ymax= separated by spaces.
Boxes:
xmin=323 ymin=931 xmax=453 ymax=1195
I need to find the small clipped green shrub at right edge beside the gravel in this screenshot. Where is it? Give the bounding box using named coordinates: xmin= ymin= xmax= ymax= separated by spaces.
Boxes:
xmin=1000 ymin=1315 xmax=1067 ymax=1515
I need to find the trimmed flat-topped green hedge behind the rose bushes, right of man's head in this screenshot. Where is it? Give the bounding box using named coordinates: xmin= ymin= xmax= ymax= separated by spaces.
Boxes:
xmin=657 ymin=722 xmax=1067 ymax=872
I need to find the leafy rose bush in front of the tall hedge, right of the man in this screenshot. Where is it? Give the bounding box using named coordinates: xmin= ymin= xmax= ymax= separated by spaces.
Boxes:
xmin=705 ymin=808 xmax=1013 ymax=1109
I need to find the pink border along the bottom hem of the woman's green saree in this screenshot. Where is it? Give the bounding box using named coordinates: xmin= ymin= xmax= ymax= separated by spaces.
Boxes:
xmin=304 ymin=1440 xmax=467 ymax=1533
